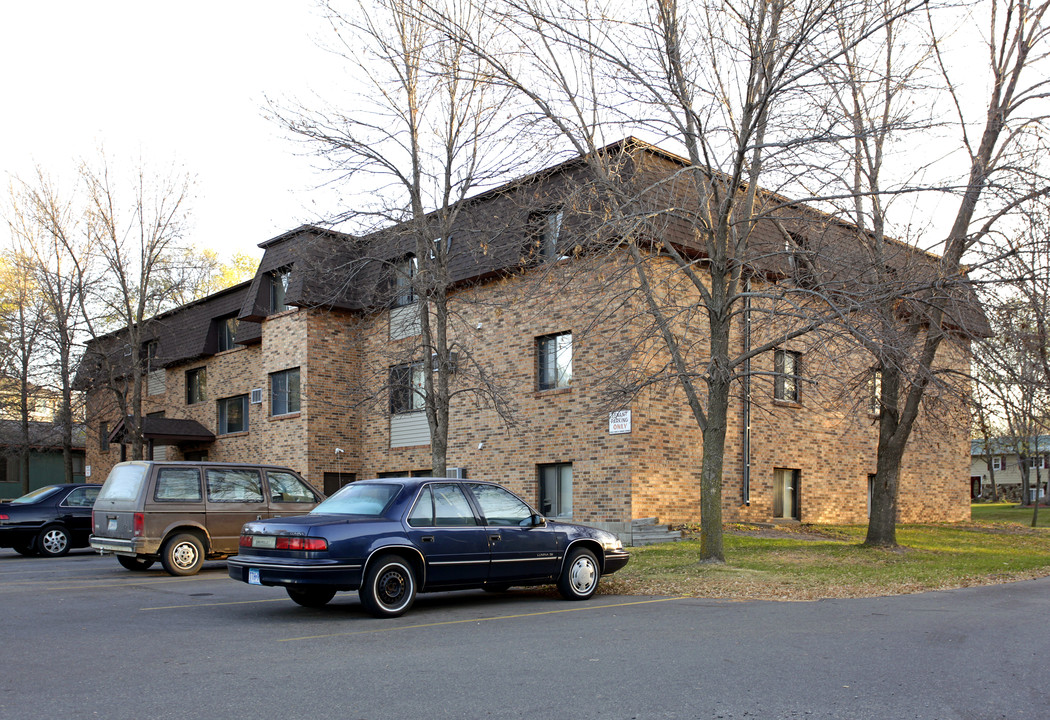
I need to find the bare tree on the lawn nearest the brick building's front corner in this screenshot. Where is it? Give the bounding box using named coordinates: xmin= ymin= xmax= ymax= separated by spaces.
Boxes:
xmin=431 ymin=0 xmax=916 ymax=562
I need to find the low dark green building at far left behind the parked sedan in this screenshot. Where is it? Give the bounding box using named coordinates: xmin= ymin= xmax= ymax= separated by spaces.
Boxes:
xmin=0 ymin=420 xmax=84 ymax=500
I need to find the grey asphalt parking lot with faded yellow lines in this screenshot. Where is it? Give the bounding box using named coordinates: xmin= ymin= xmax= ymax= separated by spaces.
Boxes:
xmin=0 ymin=550 xmax=1050 ymax=720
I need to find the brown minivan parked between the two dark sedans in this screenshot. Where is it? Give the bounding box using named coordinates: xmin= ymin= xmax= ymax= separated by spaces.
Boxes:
xmin=90 ymin=461 xmax=324 ymax=575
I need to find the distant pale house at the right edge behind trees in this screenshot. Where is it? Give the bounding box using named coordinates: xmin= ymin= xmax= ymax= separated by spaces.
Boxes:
xmin=970 ymin=435 xmax=1050 ymax=502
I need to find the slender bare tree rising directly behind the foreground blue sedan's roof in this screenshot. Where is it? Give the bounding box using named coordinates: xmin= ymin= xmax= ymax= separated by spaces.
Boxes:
xmin=276 ymin=0 xmax=529 ymax=475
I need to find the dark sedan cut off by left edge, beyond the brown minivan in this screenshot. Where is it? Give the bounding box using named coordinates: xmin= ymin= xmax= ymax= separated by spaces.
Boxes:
xmin=0 ymin=483 xmax=102 ymax=557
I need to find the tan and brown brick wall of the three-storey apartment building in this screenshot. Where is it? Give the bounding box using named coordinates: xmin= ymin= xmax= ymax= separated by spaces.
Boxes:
xmin=79 ymin=262 xmax=969 ymax=523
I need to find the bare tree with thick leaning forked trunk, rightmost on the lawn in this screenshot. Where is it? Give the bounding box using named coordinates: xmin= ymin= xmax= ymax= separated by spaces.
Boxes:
xmin=818 ymin=0 xmax=1048 ymax=547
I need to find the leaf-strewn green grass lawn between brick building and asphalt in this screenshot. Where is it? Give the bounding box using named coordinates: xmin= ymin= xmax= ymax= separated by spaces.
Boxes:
xmin=602 ymin=518 xmax=1050 ymax=600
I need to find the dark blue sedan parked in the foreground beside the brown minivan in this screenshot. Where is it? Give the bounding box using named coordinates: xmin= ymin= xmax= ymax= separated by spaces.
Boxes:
xmin=228 ymin=478 xmax=630 ymax=617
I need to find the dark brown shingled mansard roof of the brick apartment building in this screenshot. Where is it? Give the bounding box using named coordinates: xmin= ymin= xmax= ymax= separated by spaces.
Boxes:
xmin=78 ymin=137 xmax=990 ymax=379
